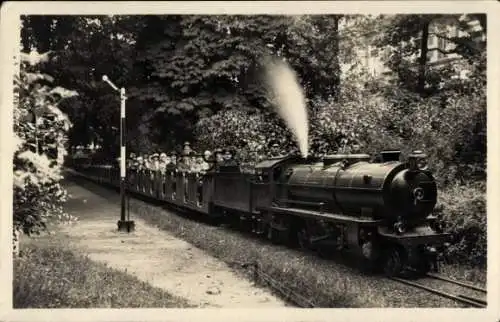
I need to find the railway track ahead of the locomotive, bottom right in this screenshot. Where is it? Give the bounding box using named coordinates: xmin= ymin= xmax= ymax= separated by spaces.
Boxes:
xmin=390 ymin=274 xmax=487 ymax=308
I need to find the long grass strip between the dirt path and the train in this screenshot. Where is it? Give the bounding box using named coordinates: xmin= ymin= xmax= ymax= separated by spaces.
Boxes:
xmin=130 ymin=200 xmax=368 ymax=307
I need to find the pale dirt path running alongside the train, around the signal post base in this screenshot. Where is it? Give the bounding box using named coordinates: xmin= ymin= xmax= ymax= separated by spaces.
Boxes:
xmin=57 ymin=182 xmax=285 ymax=308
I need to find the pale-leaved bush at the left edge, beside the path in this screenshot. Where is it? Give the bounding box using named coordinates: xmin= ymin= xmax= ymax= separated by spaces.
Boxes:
xmin=13 ymin=52 xmax=76 ymax=252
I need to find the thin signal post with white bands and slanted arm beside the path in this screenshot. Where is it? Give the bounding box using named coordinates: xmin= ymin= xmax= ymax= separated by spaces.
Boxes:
xmin=102 ymin=75 xmax=135 ymax=232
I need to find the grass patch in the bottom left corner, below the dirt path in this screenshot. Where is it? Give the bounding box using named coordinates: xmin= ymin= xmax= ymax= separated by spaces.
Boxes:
xmin=13 ymin=238 xmax=190 ymax=309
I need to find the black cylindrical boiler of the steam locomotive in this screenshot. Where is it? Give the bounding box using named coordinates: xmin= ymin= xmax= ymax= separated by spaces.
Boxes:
xmin=279 ymin=151 xmax=437 ymax=228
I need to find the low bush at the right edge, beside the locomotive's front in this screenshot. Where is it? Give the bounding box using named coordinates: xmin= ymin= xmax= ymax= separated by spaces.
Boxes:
xmin=436 ymin=182 xmax=487 ymax=267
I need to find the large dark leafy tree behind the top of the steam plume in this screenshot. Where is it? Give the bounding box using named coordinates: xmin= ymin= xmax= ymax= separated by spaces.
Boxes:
xmin=129 ymin=16 xmax=348 ymax=151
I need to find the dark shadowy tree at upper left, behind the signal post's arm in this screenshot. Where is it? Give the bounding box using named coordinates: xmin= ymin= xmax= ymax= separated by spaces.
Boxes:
xmin=21 ymin=16 xmax=142 ymax=153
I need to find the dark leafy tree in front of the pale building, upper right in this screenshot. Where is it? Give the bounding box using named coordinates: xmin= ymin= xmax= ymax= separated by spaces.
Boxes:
xmin=374 ymin=14 xmax=486 ymax=95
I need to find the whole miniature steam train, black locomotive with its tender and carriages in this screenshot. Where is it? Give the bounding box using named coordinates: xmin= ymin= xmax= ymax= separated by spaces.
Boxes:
xmin=77 ymin=151 xmax=449 ymax=276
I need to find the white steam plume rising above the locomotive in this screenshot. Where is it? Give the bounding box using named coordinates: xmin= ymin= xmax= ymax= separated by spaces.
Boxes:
xmin=264 ymin=58 xmax=309 ymax=158
